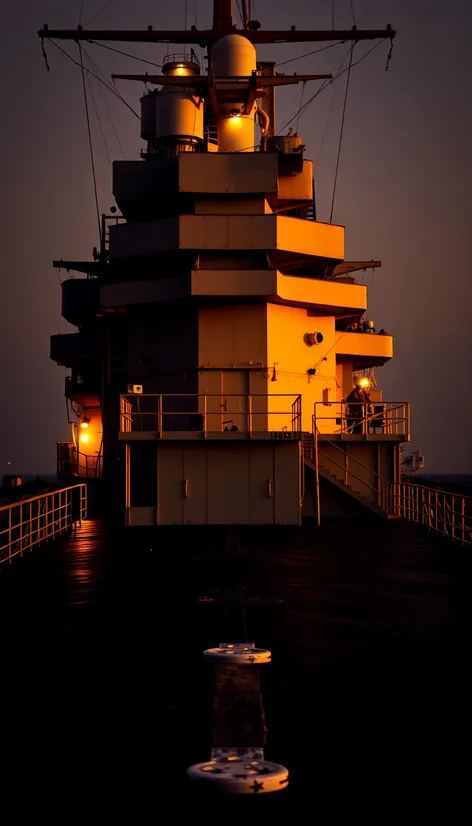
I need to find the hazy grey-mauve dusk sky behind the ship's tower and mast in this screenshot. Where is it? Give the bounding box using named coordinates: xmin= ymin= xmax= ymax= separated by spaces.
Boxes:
xmin=0 ymin=0 xmax=472 ymax=476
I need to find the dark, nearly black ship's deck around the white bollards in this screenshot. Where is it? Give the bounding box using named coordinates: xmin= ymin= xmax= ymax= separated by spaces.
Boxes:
xmin=0 ymin=517 xmax=472 ymax=812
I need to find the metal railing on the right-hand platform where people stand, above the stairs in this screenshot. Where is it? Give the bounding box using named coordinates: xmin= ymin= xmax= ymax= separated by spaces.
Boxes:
xmin=314 ymin=401 xmax=410 ymax=441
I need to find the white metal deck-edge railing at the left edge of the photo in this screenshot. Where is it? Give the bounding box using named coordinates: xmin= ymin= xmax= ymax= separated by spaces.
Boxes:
xmin=0 ymin=484 xmax=87 ymax=564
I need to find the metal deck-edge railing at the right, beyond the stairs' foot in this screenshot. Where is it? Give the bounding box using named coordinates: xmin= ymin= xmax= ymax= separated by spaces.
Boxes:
xmin=396 ymin=482 xmax=472 ymax=545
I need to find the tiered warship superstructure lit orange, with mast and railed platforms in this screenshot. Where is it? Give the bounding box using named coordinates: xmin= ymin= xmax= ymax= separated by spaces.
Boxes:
xmin=39 ymin=0 xmax=410 ymax=526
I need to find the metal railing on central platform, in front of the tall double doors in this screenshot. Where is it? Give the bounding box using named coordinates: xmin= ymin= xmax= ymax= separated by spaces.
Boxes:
xmin=120 ymin=393 xmax=302 ymax=438
